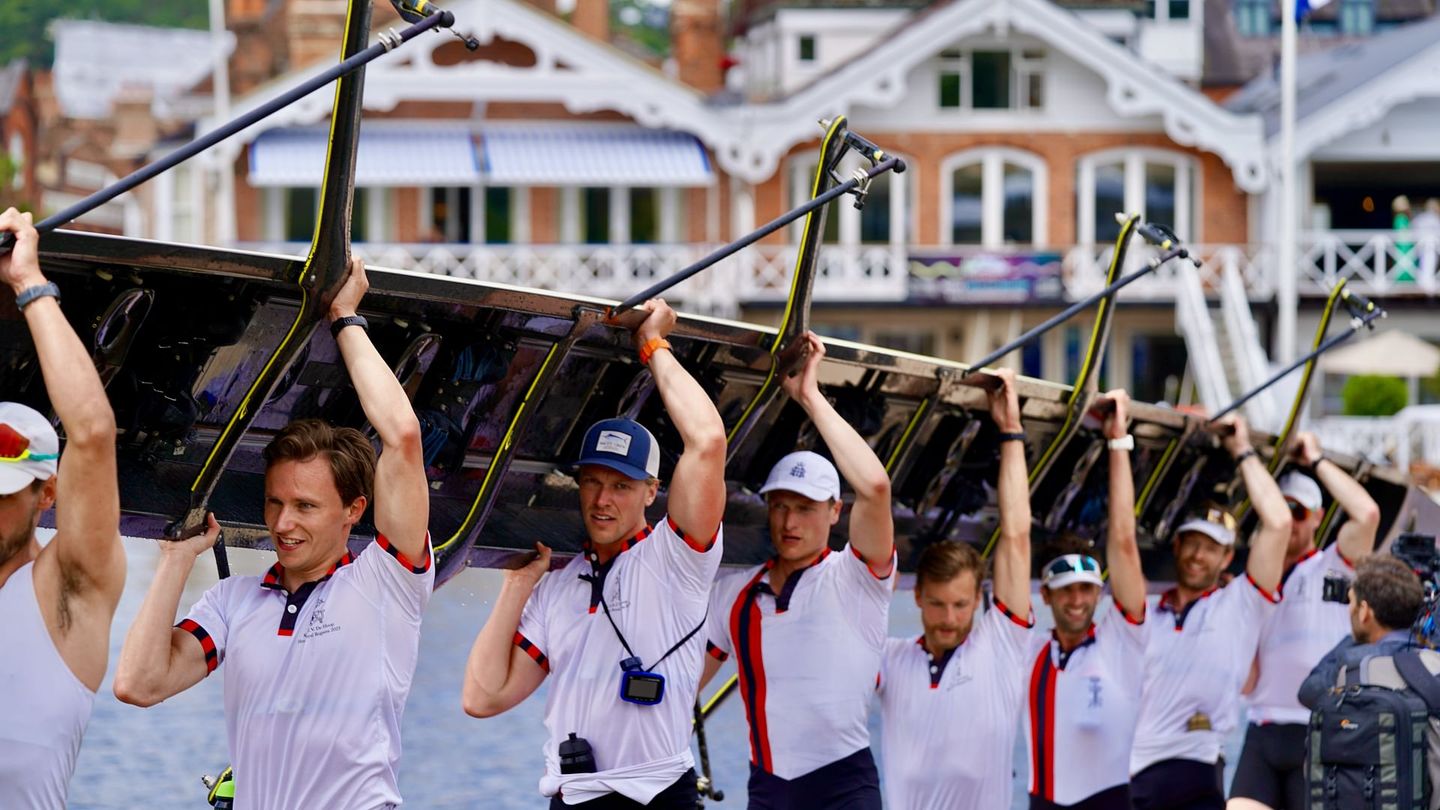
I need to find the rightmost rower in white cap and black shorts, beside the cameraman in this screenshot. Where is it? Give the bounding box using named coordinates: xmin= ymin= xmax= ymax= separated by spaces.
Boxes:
xmin=1228 ymin=432 xmax=1380 ymax=810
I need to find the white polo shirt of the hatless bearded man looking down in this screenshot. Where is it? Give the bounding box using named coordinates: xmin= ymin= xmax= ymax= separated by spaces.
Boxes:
xmin=878 ymin=600 xmax=1034 ymax=810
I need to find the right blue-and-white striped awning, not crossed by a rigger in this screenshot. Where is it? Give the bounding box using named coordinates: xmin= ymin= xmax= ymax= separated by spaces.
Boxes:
xmin=481 ymin=124 xmax=714 ymax=186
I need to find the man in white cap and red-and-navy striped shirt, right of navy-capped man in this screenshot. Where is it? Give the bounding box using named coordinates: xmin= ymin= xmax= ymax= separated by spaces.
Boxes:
xmin=700 ymin=333 xmax=896 ymax=810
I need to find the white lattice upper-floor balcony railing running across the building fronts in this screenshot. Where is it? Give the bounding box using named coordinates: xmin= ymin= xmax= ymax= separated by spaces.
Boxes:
xmin=245 ymin=231 xmax=1440 ymax=316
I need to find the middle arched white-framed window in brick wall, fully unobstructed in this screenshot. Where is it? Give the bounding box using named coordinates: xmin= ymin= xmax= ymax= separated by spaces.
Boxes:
xmin=940 ymin=147 xmax=1047 ymax=248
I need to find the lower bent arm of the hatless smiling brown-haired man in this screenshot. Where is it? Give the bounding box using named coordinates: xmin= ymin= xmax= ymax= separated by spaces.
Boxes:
xmin=115 ymin=515 xmax=220 ymax=706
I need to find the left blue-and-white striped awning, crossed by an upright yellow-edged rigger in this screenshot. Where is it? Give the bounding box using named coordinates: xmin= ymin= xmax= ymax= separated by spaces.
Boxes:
xmin=248 ymin=124 xmax=481 ymax=186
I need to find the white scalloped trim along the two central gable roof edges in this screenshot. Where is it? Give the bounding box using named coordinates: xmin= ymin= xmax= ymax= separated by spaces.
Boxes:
xmin=202 ymin=0 xmax=1267 ymax=192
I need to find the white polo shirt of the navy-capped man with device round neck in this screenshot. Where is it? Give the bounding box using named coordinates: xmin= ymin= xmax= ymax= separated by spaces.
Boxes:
xmin=516 ymin=517 xmax=723 ymax=804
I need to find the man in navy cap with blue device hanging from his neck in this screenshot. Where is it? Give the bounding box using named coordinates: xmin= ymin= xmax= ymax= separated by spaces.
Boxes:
xmin=461 ymin=298 xmax=726 ymax=810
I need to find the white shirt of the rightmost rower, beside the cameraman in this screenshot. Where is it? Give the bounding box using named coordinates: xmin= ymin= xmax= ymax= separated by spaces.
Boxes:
xmin=1246 ymin=543 xmax=1355 ymax=724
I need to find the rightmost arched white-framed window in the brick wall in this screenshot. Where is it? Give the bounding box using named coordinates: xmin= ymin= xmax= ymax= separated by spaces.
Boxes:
xmin=1076 ymin=148 xmax=1200 ymax=245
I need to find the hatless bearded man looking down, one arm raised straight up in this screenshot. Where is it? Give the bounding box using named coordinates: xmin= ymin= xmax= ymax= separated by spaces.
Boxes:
xmin=878 ymin=370 xmax=1034 ymax=810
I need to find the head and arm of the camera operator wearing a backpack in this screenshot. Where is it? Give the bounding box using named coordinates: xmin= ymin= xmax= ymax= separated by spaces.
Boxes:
xmin=1300 ymin=550 xmax=1434 ymax=709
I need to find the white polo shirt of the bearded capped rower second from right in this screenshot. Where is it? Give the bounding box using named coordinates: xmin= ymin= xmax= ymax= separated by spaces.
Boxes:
xmin=1130 ymin=574 xmax=1280 ymax=775
